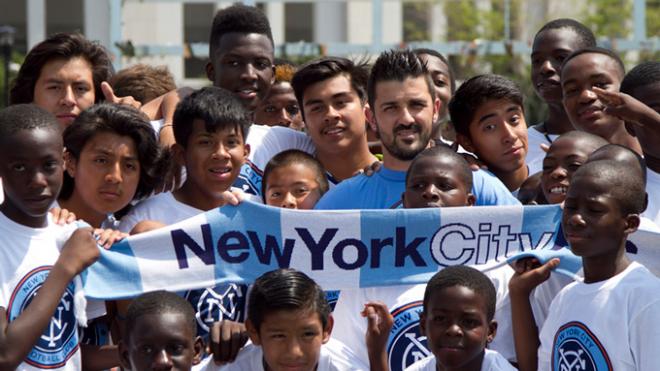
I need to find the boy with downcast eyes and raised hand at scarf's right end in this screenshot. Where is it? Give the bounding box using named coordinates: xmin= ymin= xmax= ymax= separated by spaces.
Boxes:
xmin=509 ymin=160 xmax=660 ymax=370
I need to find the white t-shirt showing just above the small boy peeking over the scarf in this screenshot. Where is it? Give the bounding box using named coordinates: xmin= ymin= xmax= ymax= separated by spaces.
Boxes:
xmin=234 ymin=125 xmax=316 ymax=195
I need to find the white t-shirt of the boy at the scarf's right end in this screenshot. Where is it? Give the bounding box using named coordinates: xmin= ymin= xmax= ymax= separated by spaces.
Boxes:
xmin=538 ymin=262 xmax=660 ymax=371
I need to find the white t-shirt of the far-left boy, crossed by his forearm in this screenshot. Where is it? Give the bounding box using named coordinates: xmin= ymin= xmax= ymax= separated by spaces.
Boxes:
xmin=0 ymin=213 xmax=81 ymax=370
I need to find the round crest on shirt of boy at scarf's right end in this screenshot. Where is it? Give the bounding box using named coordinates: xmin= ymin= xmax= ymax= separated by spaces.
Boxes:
xmin=552 ymin=322 xmax=612 ymax=371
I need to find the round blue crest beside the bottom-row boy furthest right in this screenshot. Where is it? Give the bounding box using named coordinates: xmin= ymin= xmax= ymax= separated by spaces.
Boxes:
xmin=387 ymin=300 xmax=431 ymax=371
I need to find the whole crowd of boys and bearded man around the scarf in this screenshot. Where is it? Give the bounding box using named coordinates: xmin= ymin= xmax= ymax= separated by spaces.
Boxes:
xmin=0 ymin=5 xmax=660 ymax=371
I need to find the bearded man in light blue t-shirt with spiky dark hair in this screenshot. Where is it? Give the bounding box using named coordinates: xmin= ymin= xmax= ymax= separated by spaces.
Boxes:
xmin=316 ymin=50 xmax=519 ymax=209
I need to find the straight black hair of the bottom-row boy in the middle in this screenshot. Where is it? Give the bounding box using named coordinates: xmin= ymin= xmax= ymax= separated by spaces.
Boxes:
xmin=247 ymin=269 xmax=330 ymax=331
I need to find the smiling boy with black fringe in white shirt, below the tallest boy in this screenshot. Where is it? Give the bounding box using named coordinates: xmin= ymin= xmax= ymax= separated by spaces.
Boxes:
xmin=119 ymin=87 xmax=256 ymax=346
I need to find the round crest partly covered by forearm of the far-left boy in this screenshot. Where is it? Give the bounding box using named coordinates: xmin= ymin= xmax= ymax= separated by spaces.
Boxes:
xmin=7 ymin=266 xmax=78 ymax=368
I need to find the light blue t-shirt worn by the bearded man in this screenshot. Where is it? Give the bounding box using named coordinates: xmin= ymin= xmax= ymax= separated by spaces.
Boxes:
xmin=315 ymin=166 xmax=520 ymax=210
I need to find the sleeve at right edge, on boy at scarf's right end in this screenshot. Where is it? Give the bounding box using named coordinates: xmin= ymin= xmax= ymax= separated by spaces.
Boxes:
xmin=629 ymin=300 xmax=660 ymax=370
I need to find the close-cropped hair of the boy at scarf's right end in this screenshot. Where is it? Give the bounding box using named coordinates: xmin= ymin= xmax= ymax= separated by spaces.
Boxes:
xmin=568 ymin=160 xmax=646 ymax=215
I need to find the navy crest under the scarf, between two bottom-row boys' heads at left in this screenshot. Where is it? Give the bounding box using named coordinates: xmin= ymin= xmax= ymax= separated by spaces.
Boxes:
xmin=186 ymin=283 xmax=247 ymax=335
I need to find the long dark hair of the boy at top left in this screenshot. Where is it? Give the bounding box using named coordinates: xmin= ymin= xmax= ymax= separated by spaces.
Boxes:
xmin=9 ymin=33 xmax=113 ymax=104
